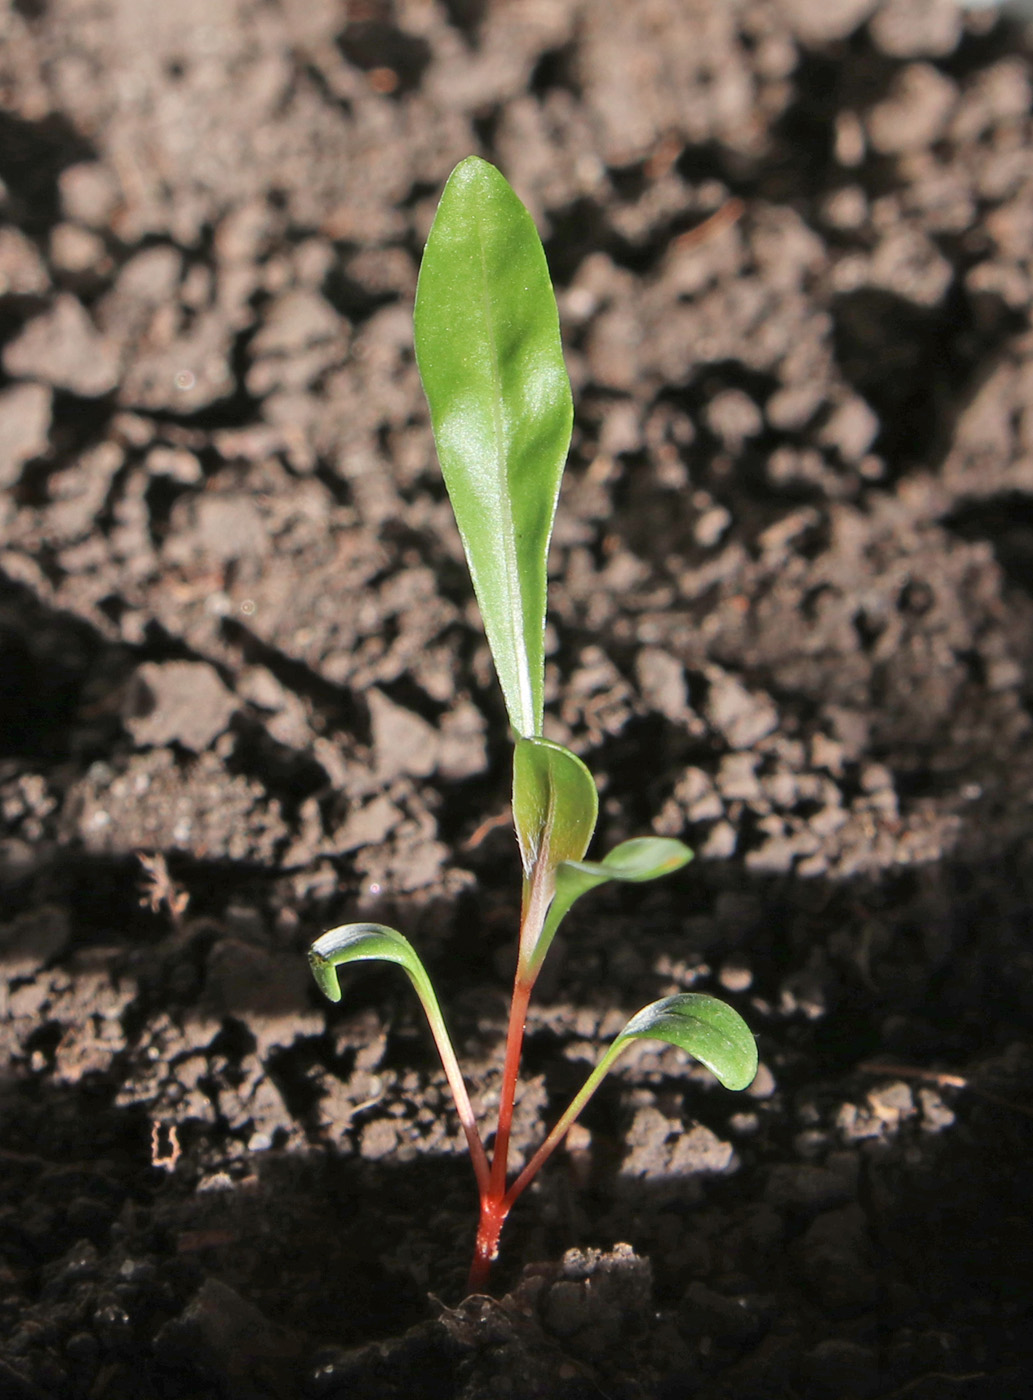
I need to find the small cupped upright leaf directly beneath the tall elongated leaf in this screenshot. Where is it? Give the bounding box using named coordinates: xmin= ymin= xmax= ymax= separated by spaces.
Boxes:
xmin=512 ymin=739 xmax=599 ymax=876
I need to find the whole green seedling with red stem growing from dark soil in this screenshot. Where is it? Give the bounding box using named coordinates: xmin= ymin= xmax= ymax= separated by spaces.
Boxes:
xmin=309 ymin=155 xmax=757 ymax=1292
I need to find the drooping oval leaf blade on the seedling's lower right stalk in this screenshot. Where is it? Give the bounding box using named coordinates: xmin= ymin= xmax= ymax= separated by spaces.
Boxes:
xmin=605 ymin=991 xmax=757 ymax=1089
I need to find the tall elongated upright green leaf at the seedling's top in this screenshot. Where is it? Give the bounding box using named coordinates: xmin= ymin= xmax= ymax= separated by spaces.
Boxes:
xmin=413 ymin=155 xmax=574 ymax=736
